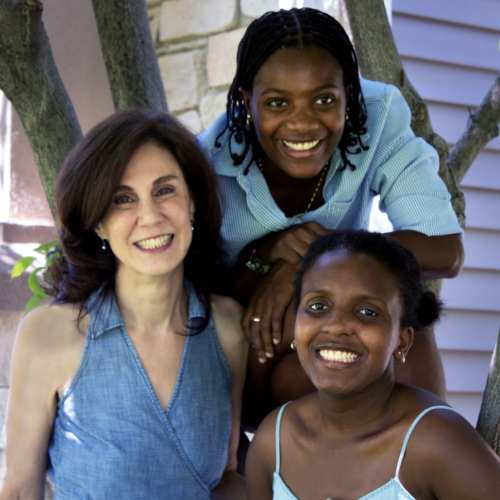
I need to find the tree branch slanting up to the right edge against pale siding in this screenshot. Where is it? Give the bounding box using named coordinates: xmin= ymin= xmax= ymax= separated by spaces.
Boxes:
xmin=448 ymin=73 xmax=500 ymax=182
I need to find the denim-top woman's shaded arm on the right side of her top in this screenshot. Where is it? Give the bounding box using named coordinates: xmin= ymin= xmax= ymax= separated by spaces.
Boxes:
xmin=211 ymin=295 xmax=248 ymax=500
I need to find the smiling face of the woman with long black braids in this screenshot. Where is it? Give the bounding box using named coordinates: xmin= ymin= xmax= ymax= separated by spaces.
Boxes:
xmin=241 ymin=46 xmax=348 ymax=179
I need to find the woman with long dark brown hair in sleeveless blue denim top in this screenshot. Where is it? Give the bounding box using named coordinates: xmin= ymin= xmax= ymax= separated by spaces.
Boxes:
xmin=0 ymin=110 xmax=247 ymax=500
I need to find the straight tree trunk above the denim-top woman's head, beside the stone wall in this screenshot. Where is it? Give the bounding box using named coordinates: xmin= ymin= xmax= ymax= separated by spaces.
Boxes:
xmin=92 ymin=0 xmax=168 ymax=112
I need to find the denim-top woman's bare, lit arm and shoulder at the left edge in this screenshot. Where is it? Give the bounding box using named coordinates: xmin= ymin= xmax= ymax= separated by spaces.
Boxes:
xmin=0 ymin=306 xmax=83 ymax=500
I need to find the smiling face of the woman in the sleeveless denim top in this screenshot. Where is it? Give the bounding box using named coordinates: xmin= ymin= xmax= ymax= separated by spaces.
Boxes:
xmin=96 ymin=144 xmax=195 ymax=277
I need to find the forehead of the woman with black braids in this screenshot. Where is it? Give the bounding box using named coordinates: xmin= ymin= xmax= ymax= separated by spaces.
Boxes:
xmin=254 ymin=45 xmax=344 ymax=86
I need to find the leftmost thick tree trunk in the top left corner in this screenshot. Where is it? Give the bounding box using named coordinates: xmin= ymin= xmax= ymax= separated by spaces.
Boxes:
xmin=0 ymin=0 xmax=82 ymax=219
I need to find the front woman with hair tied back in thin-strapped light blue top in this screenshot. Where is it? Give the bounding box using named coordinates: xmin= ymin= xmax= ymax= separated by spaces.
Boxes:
xmin=247 ymin=231 xmax=500 ymax=500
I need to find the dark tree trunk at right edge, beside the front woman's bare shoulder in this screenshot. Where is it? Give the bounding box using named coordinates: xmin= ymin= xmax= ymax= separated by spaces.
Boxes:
xmin=477 ymin=333 xmax=500 ymax=456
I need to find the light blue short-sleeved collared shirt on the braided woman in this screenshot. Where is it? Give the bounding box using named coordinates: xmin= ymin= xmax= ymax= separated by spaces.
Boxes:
xmin=198 ymin=79 xmax=462 ymax=265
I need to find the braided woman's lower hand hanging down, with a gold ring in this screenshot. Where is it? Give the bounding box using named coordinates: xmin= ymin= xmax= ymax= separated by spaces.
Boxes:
xmin=242 ymin=260 xmax=298 ymax=363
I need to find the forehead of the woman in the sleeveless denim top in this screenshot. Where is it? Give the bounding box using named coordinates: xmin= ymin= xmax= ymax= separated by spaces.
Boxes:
xmin=120 ymin=143 xmax=184 ymax=185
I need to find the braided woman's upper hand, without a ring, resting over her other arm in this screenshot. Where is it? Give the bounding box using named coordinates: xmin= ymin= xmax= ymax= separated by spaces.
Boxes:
xmin=257 ymin=222 xmax=330 ymax=265
